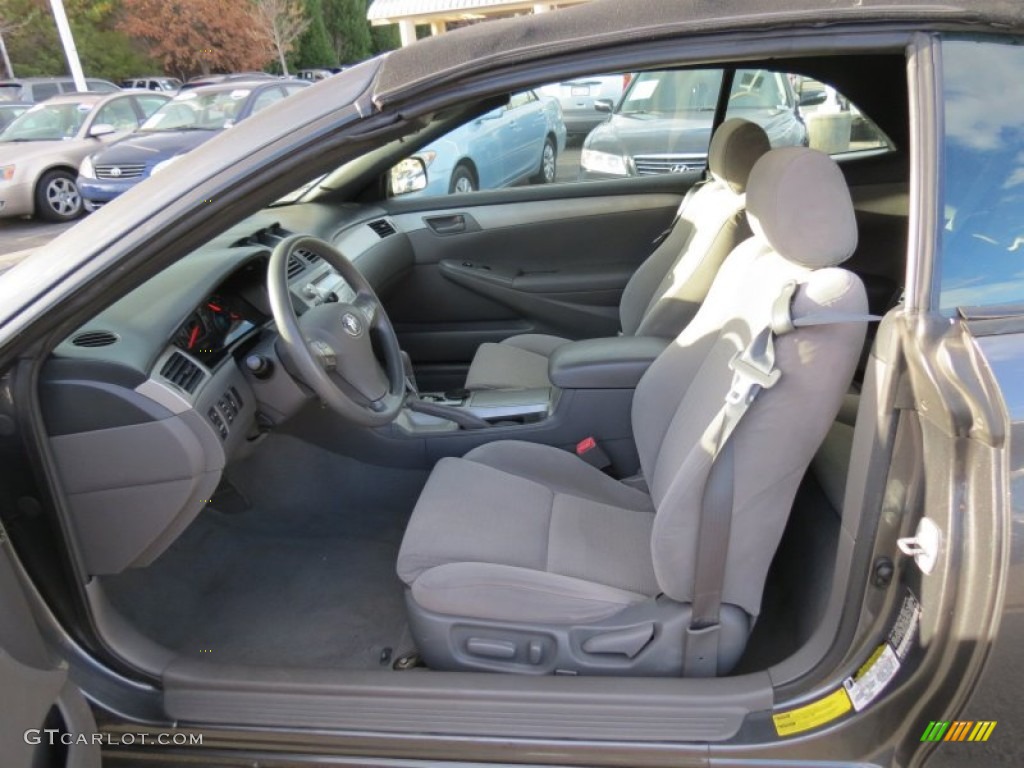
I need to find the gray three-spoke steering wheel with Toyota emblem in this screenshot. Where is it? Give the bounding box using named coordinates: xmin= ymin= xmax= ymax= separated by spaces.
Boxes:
xmin=267 ymin=234 xmax=406 ymax=427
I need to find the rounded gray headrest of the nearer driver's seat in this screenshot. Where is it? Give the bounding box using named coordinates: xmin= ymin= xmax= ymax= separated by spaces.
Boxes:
xmin=746 ymin=146 xmax=857 ymax=269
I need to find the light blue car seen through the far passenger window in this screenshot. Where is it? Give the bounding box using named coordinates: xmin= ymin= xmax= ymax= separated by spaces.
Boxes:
xmin=394 ymin=90 xmax=566 ymax=196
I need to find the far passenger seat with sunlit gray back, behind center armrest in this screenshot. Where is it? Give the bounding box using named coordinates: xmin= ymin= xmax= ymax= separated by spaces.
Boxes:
xmin=466 ymin=118 xmax=769 ymax=389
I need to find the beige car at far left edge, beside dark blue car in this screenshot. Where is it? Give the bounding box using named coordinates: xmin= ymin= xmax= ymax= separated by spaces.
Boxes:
xmin=0 ymin=93 xmax=168 ymax=221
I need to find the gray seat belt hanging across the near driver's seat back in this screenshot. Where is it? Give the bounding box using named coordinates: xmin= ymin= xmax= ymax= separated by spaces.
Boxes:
xmin=683 ymin=281 xmax=881 ymax=677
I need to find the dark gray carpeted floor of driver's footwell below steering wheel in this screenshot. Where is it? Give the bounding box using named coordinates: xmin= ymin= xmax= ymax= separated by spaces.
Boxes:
xmin=103 ymin=436 xmax=427 ymax=669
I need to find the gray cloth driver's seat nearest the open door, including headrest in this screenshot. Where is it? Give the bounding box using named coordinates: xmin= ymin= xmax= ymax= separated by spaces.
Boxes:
xmin=397 ymin=147 xmax=867 ymax=676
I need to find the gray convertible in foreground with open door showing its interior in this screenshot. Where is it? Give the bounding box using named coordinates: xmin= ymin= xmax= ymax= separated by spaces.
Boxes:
xmin=0 ymin=0 xmax=1024 ymax=768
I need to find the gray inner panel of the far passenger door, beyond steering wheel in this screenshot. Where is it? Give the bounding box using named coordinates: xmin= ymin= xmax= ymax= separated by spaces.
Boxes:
xmin=386 ymin=185 xmax=681 ymax=382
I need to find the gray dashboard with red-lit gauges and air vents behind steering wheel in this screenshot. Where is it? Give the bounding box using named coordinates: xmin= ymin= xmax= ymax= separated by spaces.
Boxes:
xmin=39 ymin=204 xmax=413 ymax=574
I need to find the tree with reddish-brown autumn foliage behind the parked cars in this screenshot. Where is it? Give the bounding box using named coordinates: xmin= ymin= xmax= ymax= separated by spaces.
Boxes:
xmin=118 ymin=0 xmax=274 ymax=75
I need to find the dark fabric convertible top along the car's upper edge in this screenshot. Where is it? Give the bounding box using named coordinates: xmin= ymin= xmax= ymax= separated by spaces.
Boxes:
xmin=374 ymin=0 xmax=1024 ymax=106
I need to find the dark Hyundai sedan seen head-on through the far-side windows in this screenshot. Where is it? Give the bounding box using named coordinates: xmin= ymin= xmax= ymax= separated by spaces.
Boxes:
xmin=580 ymin=69 xmax=807 ymax=179
